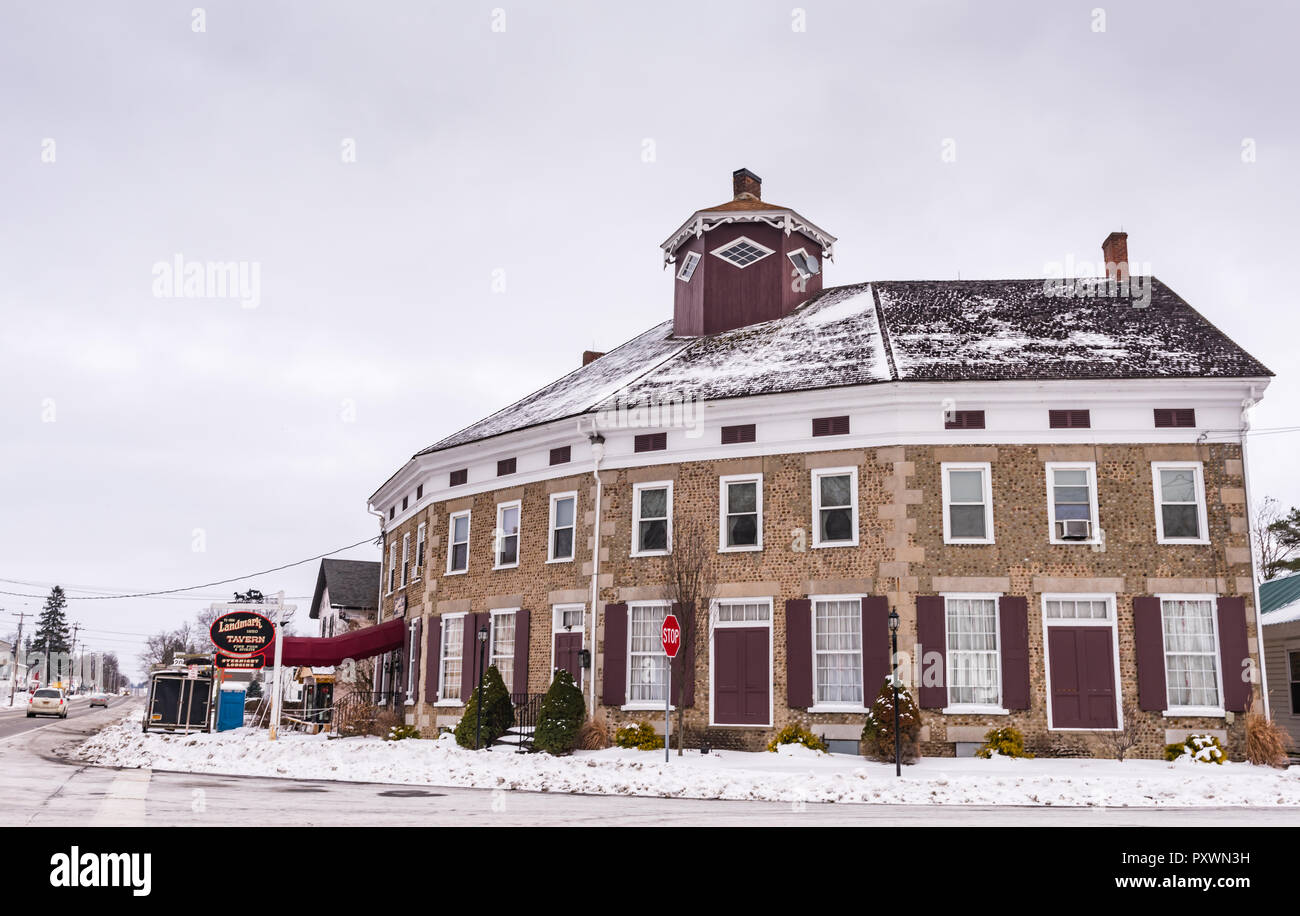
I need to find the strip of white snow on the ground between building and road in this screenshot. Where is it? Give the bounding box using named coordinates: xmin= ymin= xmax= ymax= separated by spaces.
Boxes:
xmin=78 ymin=716 xmax=1300 ymax=807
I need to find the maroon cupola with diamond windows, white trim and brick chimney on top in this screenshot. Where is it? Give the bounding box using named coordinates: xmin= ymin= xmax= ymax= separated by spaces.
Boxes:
xmin=660 ymin=169 xmax=835 ymax=337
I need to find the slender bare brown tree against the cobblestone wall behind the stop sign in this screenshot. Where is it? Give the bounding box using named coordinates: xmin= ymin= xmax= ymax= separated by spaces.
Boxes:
xmin=662 ymin=518 xmax=718 ymax=756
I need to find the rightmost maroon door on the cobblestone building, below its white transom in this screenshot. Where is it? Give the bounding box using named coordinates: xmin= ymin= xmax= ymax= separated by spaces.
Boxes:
xmin=1048 ymin=626 xmax=1118 ymax=729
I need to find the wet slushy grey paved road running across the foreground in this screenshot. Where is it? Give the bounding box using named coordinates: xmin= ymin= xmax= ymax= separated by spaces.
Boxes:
xmin=0 ymin=700 xmax=1300 ymax=826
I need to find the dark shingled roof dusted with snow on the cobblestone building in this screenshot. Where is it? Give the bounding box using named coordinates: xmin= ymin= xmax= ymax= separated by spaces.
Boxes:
xmin=419 ymin=277 xmax=1273 ymax=455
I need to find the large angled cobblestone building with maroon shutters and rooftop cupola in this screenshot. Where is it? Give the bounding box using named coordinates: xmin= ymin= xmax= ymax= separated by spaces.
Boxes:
xmin=369 ymin=169 xmax=1271 ymax=757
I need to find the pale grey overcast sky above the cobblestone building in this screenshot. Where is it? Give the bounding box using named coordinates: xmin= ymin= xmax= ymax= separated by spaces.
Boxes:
xmin=0 ymin=0 xmax=1300 ymax=677
